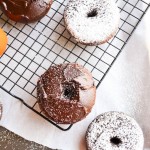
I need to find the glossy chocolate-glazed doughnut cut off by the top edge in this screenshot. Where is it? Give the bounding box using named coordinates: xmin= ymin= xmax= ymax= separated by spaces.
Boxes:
xmin=0 ymin=0 xmax=52 ymax=23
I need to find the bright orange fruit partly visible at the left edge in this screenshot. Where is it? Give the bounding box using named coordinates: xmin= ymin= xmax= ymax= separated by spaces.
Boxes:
xmin=0 ymin=28 xmax=8 ymax=57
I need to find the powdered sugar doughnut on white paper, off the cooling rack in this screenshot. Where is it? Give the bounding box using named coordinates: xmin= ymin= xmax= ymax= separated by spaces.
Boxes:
xmin=86 ymin=112 xmax=144 ymax=150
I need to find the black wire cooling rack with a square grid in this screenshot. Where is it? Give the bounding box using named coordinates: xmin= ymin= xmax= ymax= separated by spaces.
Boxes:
xmin=0 ymin=0 xmax=150 ymax=131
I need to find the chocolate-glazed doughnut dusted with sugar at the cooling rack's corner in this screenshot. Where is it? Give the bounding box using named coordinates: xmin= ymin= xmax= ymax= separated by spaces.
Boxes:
xmin=37 ymin=63 xmax=96 ymax=124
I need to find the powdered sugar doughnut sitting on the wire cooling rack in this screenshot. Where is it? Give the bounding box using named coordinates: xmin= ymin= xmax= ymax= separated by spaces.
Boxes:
xmin=64 ymin=0 xmax=120 ymax=45
